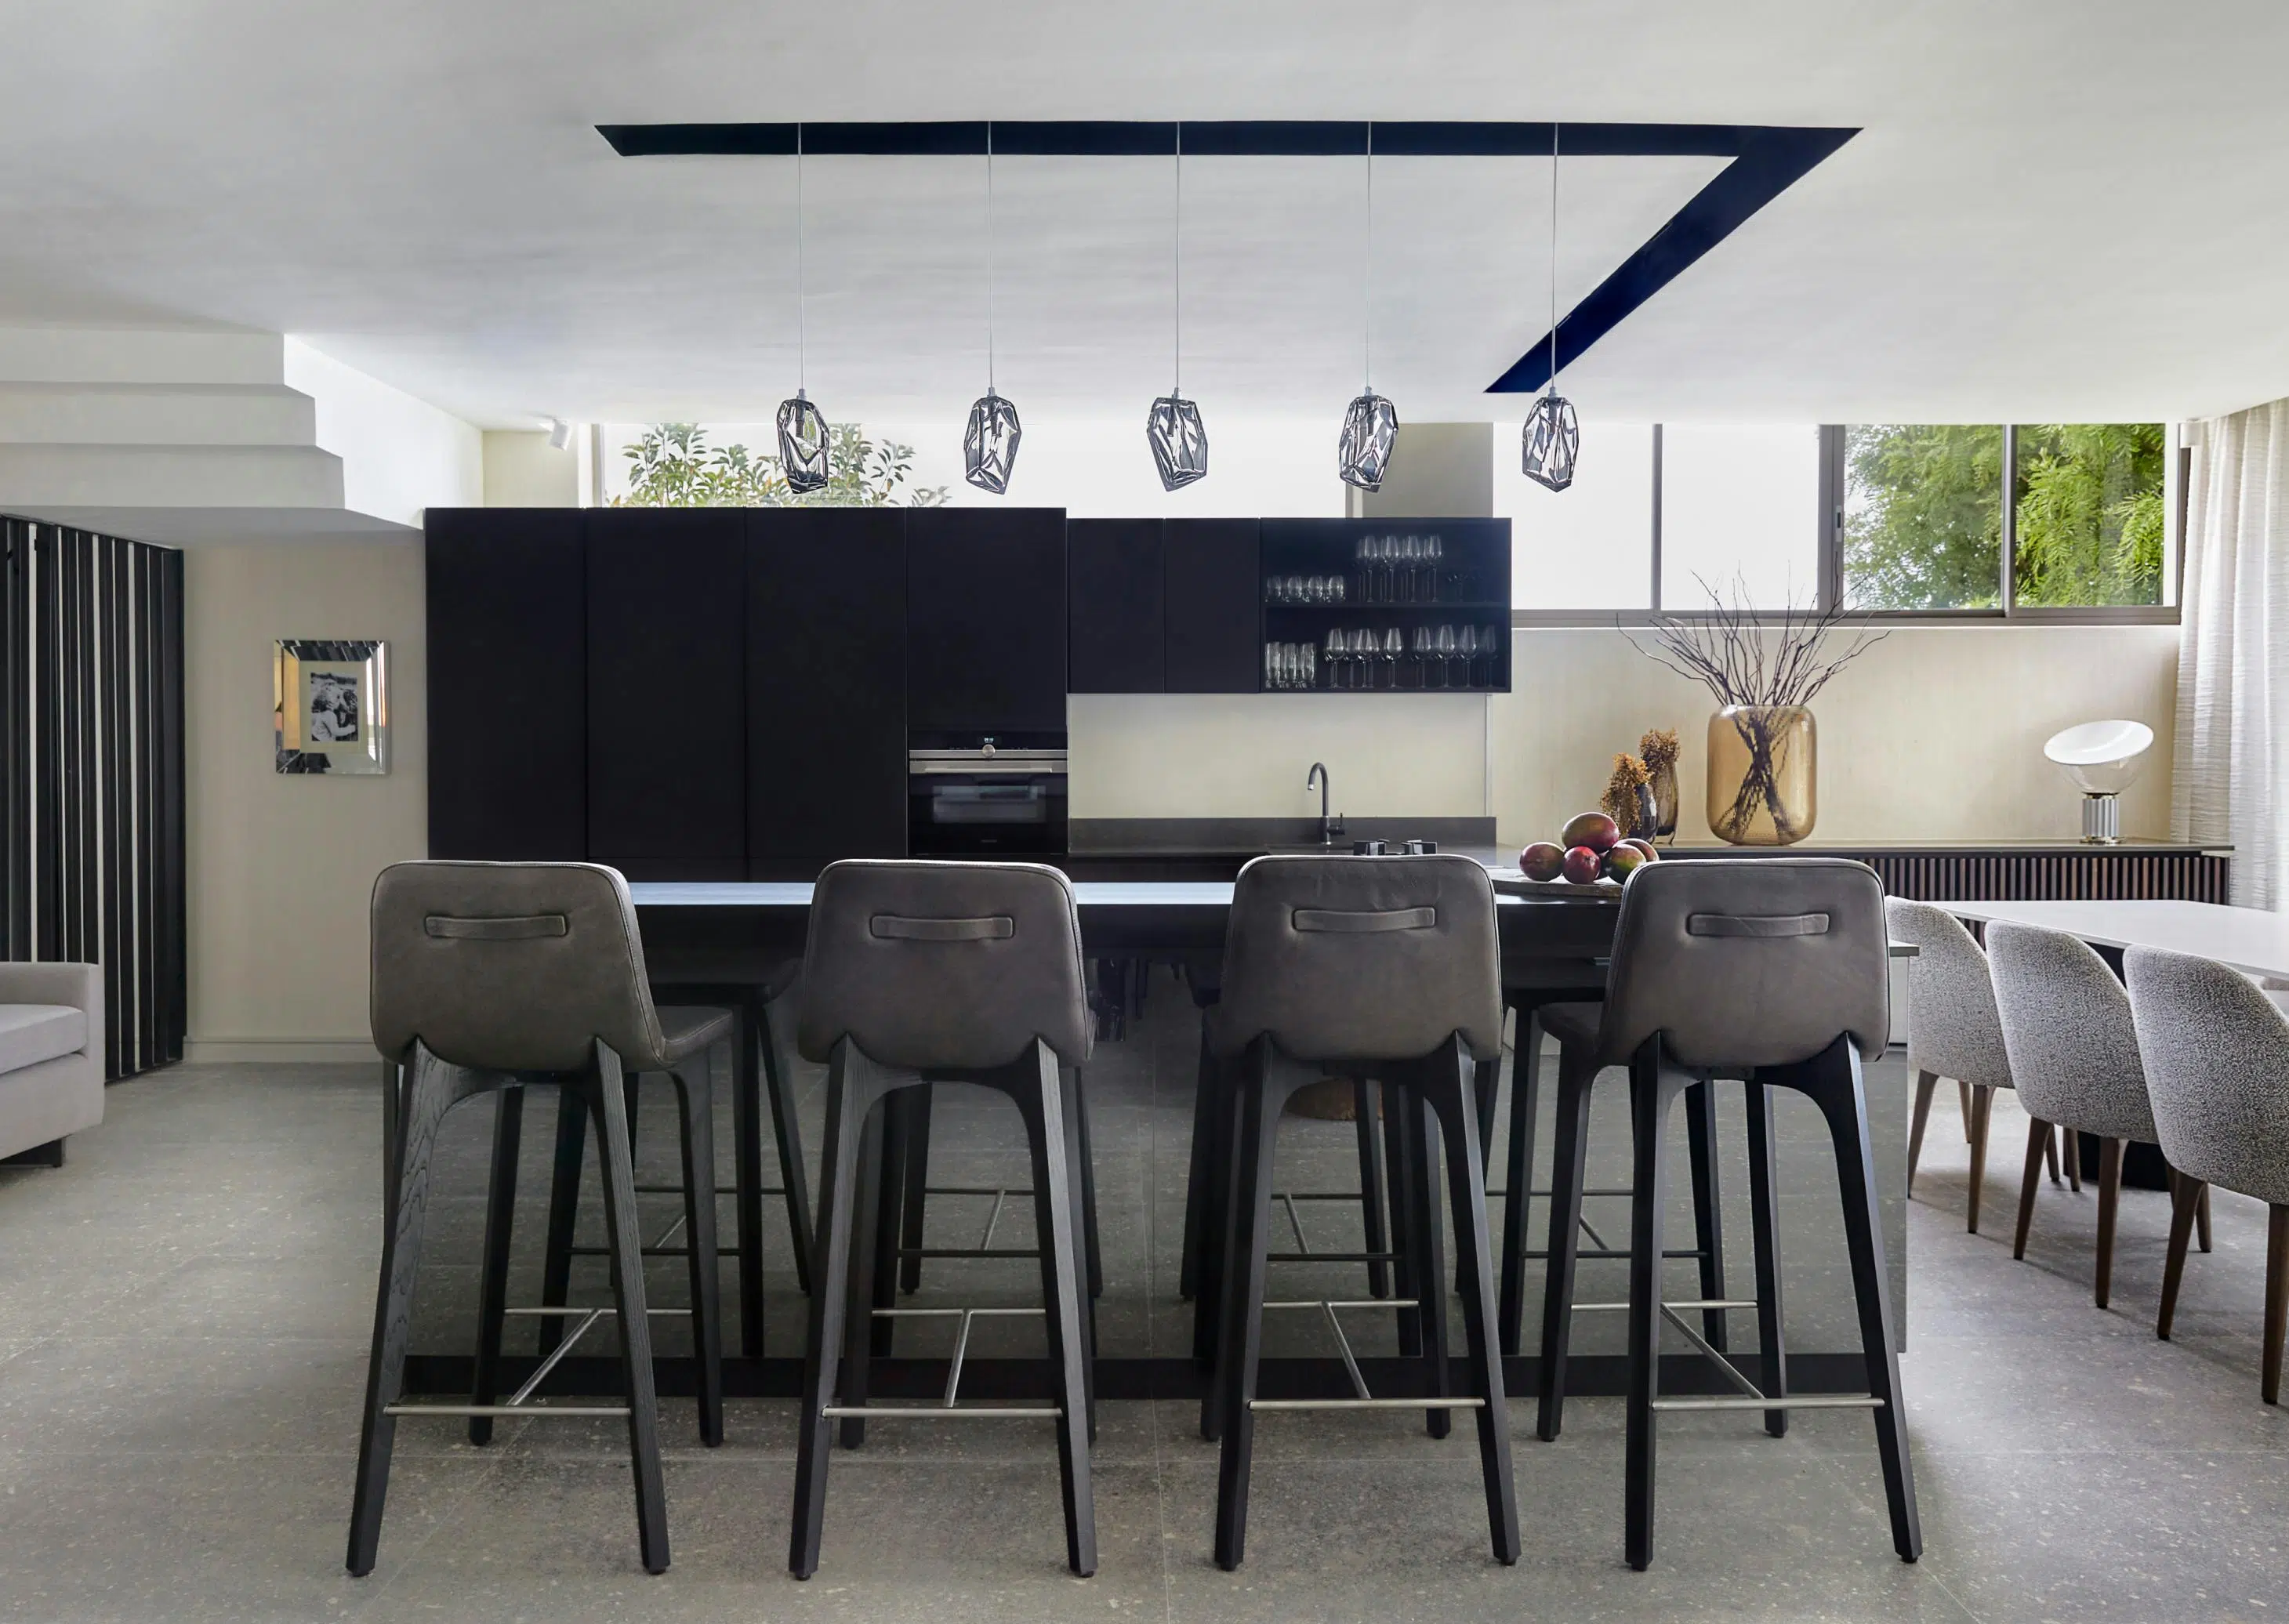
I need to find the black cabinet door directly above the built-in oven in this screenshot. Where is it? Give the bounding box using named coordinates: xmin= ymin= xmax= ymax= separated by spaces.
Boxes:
xmin=906 ymin=508 xmax=1067 ymax=743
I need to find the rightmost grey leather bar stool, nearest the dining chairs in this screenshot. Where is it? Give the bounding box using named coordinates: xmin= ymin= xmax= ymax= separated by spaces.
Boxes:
xmin=1540 ymin=857 xmax=1923 ymax=1569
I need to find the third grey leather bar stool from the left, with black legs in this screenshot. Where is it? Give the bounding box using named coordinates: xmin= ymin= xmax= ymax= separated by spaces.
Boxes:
xmin=1202 ymin=855 xmax=1518 ymax=1569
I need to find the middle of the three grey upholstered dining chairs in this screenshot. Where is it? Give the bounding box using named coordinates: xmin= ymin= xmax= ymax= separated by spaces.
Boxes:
xmin=1987 ymin=922 xmax=2154 ymax=1308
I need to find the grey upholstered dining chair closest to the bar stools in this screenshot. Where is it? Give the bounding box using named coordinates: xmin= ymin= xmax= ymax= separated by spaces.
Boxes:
xmin=1884 ymin=897 xmax=2041 ymax=1235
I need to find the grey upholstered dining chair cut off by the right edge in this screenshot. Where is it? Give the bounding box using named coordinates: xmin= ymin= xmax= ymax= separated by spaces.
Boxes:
xmin=2122 ymin=947 xmax=2289 ymax=1405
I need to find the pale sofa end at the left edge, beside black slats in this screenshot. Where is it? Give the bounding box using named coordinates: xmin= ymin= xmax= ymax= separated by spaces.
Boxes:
xmin=0 ymin=963 xmax=103 ymax=1166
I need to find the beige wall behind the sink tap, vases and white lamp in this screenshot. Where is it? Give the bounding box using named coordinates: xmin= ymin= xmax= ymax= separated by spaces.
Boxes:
xmin=1069 ymin=627 xmax=2177 ymax=844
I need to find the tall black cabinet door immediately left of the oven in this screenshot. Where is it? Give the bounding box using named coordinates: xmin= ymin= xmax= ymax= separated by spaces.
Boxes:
xmin=746 ymin=508 xmax=906 ymax=879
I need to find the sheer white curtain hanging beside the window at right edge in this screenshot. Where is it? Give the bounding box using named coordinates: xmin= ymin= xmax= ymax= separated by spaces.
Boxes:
xmin=2170 ymin=401 xmax=2289 ymax=908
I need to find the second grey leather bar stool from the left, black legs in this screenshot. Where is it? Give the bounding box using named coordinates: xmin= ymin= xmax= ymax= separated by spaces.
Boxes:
xmin=787 ymin=860 xmax=1097 ymax=1579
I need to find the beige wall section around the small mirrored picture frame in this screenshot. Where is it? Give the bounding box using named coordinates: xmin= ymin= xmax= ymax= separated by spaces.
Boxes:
xmin=183 ymin=542 xmax=428 ymax=1059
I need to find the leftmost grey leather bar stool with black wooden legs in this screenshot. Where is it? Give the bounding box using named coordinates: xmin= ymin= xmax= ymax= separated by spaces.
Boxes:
xmin=348 ymin=862 xmax=732 ymax=1576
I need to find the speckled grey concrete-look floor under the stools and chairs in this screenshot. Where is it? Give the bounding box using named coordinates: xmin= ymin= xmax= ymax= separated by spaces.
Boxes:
xmin=0 ymin=997 xmax=2289 ymax=1624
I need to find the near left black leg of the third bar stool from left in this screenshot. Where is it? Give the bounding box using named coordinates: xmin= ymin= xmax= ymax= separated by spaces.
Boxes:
xmin=1216 ymin=1039 xmax=1300 ymax=1574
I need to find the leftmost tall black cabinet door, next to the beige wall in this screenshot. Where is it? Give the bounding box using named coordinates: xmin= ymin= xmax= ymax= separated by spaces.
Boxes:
xmin=423 ymin=508 xmax=588 ymax=862
